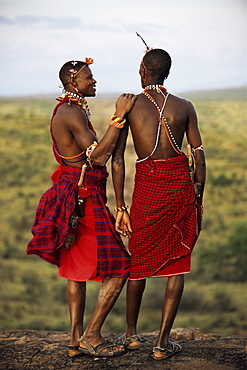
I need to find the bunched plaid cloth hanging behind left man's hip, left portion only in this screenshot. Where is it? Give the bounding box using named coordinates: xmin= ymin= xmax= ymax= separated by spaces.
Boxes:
xmin=27 ymin=165 xmax=81 ymax=265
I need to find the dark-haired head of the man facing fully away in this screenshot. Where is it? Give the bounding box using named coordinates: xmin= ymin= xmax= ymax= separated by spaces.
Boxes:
xmin=140 ymin=49 xmax=172 ymax=87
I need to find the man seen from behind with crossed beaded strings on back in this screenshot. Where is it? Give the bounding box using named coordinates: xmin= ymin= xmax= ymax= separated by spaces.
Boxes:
xmin=112 ymin=44 xmax=205 ymax=360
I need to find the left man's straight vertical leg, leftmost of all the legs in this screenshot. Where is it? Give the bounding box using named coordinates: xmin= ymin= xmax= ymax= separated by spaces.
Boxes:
xmin=67 ymin=280 xmax=86 ymax=352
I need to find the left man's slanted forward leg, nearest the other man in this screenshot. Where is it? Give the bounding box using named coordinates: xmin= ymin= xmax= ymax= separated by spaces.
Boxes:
xmin=81 ymin=277 xmax=126 ymax=351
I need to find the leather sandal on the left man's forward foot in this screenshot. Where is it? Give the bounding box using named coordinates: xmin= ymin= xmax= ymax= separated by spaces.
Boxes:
xmin=79 ymin=336 xmax=125 ymax=357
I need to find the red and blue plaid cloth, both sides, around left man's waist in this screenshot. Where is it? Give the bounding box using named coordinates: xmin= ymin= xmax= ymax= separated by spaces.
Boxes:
xmin=27 ymin=165 xmax=130 ymax=278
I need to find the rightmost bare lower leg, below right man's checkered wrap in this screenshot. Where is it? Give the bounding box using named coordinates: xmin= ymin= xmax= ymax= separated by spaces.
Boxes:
xmin=156 ymin=275 xmax=184 ymax=350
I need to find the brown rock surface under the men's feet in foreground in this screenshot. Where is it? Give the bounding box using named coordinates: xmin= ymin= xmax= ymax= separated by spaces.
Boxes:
xmin=0 ymin=328 xmax=247 ymax=370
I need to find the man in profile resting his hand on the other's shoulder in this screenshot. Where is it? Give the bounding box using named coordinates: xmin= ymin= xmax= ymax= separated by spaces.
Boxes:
xmin=27 ymin=58 xmax=136 ymax=357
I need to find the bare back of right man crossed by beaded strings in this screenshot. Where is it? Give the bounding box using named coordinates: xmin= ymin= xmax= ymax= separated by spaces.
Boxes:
xmin=128 ymin=91 xmax=201 ymax=159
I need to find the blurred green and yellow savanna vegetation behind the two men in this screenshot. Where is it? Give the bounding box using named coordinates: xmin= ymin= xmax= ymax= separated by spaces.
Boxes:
xmin=0 ymin=91 xmax=247 ymax=335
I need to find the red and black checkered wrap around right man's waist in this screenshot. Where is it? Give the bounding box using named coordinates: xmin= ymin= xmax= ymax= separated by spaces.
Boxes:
xmin=129 ymin=153 xmax=201 ymax=279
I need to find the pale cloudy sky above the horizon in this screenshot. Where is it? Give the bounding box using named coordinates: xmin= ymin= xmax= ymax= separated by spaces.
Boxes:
xmin=0 ymin=0 xmax=247 ymax=96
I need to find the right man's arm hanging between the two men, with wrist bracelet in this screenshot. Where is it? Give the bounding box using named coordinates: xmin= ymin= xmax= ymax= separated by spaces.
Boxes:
xmin=112 ymin=124 xmax=132 ymax=238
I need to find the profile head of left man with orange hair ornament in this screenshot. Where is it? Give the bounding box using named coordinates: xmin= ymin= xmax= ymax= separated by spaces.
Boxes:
xmin=59 ymin=58 xmax=96 ymax=96
